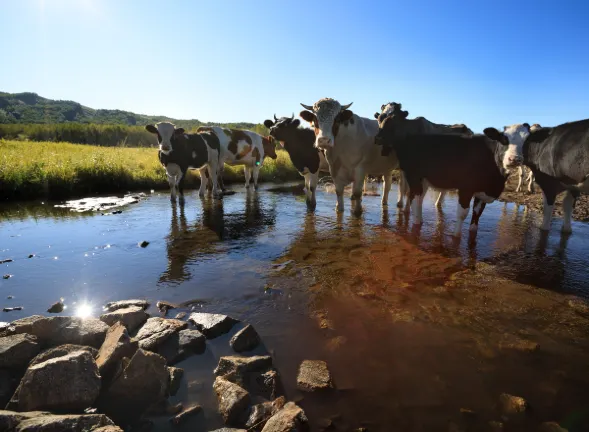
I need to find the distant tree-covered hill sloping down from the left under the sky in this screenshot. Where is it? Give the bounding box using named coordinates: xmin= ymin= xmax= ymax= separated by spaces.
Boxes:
xmin=0 ymin=92 xmax=256 ymax=129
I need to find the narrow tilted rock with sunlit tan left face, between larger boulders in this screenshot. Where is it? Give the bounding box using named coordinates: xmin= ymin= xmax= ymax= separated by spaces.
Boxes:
xmin=96 ymin=322 xmax=137 ymax=381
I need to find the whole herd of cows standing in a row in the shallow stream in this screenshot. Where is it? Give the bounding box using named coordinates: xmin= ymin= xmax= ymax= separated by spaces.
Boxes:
xmin=146 ymin=98 xmax=589 ymax=236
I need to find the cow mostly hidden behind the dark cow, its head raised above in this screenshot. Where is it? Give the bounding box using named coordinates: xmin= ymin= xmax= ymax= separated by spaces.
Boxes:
xmin=374 ymin=102 xmax=473 ymax=212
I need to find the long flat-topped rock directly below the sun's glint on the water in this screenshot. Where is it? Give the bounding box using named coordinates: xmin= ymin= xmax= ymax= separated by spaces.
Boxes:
xmin=8 ymin=316 xmax=108 ymax=348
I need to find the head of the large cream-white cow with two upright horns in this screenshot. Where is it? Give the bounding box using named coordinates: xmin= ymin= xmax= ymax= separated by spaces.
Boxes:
xmin=300 ymin=98 xmax=354 ymax=149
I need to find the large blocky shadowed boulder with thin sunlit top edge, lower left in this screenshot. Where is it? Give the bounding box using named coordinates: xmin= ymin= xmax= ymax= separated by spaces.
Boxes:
xmin=15 ymin=351 xmax=101 ymax=411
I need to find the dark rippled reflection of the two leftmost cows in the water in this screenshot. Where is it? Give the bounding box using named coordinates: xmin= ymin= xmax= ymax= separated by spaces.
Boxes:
xmin=159 ymin=191 xmax=276 ymax=283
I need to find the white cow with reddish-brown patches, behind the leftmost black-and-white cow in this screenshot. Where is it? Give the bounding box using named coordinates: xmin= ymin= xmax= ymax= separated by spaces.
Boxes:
xmin=198 ymin=126 xmax=278 ymax=190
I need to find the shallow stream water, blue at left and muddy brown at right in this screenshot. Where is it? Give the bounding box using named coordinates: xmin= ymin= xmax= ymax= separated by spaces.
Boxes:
xmin=0 ymin=185 xmax=589 ymax=431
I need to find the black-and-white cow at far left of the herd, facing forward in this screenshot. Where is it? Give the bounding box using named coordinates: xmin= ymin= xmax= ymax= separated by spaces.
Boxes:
xmin=145 ymin=122 xmax=220 ymax=203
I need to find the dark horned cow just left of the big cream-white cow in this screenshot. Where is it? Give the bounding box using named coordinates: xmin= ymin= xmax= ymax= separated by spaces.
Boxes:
xmin=264 ymin=114 xmax=329 ymax=209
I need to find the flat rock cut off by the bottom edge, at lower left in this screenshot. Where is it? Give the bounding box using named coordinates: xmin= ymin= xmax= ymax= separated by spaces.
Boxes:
xmin=15 ymin=414 xmax=115 ymax=432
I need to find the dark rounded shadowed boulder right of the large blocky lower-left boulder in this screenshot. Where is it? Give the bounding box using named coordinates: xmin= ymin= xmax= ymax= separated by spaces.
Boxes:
xmin=98 ymin=349 xmax=169 ymax=425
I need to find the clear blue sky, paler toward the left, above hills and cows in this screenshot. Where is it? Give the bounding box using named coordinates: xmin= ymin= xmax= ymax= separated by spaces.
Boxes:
xmin=0 ymin=0 xmax=589 ymax=131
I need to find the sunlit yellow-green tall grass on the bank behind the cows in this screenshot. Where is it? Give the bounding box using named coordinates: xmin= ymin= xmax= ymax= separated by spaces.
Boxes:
xmin=0 ymin=140 xmax=301 ymax=201
